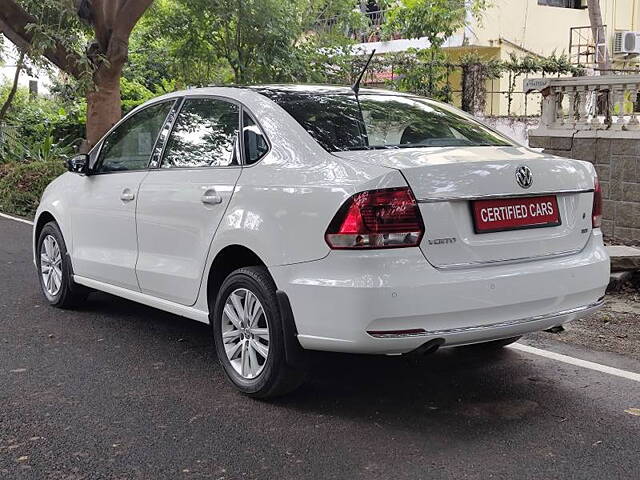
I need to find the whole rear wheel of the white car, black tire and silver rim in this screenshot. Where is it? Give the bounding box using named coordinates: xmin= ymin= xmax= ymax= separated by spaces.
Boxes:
xmin=211 ymin=267 xmax=305 ymax=398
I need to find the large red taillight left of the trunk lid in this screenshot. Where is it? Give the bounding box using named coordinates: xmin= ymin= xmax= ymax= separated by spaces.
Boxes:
xmin=325 ymin=187 xmax=424 ymax=249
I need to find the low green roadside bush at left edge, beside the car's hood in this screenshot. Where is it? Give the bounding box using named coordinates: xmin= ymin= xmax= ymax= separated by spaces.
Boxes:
xmin=0 ymin=160 xmax=65 ymax=217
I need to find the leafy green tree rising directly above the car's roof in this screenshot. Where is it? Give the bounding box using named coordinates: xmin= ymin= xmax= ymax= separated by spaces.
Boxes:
xmin=125 ymin=0 xmax=362 ymax=90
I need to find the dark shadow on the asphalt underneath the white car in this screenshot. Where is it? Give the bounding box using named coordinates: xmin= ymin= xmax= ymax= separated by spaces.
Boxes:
xmin=76 ymin=293 xmax=570 ymax=430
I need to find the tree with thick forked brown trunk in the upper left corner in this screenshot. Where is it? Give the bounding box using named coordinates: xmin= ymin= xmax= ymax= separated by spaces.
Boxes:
xmin=0 ymin=0 xmax=153 ymax=145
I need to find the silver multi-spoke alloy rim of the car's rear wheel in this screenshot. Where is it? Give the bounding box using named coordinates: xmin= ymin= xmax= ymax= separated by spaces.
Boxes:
xmin=221 ymin=288 xmax=269 ymax=380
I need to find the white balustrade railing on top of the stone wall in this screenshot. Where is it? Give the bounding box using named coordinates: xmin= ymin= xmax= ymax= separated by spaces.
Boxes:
xmin=524 ymin=75 xmax=640 ymax=130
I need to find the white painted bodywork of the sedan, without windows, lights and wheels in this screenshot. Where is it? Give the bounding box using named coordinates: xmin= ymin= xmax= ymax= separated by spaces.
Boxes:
xmin=34 ymin=87 xmax=609 ymax=354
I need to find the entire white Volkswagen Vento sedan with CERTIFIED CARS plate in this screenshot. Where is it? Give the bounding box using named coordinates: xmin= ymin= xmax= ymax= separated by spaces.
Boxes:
xmin=33 ymin=86 xmax=609 ymax=397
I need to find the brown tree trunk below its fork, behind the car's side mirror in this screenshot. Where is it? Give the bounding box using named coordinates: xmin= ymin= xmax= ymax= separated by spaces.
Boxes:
xmin=87 ymin=65 xmax=122 ymax=148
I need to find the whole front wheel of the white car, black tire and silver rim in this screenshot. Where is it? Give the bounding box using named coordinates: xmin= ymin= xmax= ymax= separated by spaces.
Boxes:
xmin=36 ymin=222 xmax=89 ymax=308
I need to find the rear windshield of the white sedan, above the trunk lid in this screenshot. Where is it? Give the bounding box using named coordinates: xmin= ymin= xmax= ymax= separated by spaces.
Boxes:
xmin=260 ymin=90 xmax=513 ymax=152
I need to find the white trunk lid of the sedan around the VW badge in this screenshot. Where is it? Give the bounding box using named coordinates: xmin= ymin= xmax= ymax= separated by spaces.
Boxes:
xmin=336 ymin=147 xmax=594 ymax=268
